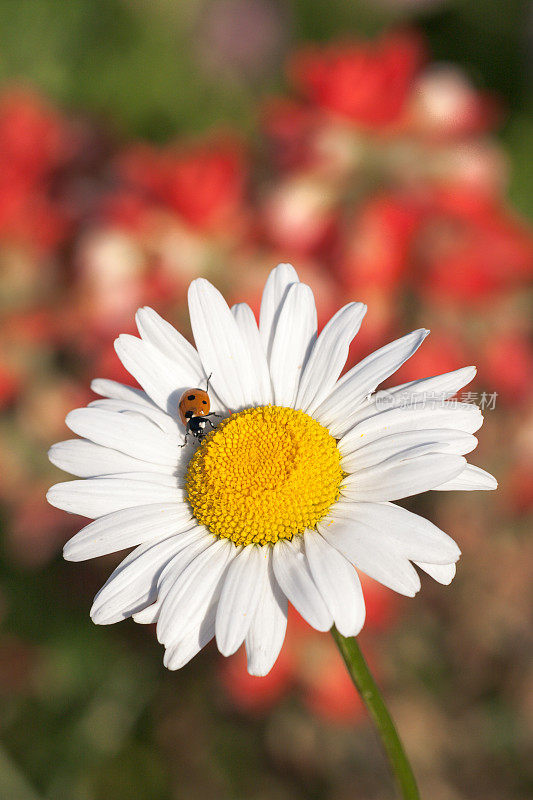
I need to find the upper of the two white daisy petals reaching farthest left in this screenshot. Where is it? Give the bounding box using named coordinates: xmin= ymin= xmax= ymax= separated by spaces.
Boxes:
xmin=48 ymin=439 xmax=176 ymax=478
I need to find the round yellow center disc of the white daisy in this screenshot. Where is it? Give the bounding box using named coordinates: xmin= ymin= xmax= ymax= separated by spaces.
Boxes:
xmin=186 ymin=406 xmax=343 ymax=545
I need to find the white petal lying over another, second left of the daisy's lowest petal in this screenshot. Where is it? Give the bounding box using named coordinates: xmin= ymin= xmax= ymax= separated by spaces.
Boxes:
xmin=157 ymin=539 xmax=235 ymax=647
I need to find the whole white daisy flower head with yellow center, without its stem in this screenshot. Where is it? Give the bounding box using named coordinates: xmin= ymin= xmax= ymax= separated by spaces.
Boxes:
xmin=48 ymin=264 xmax=496 ymax=675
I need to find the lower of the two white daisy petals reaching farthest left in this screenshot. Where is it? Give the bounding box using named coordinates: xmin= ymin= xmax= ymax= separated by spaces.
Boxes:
xmin=46 ymin=478 xmax=183 ymax=519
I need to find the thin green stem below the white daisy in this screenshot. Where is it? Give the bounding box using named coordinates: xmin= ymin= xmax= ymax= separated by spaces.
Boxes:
xmin=331 ymin=628 xmax=420 ymax=800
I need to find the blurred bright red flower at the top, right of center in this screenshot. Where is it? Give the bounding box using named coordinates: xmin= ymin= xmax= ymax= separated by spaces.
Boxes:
xmin=289 ymin=33 xmax=425 ymax=129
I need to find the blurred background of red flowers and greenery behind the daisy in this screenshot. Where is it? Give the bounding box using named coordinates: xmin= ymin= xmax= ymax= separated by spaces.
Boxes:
xmin=0 ymin=0 xmax=533 ymax=800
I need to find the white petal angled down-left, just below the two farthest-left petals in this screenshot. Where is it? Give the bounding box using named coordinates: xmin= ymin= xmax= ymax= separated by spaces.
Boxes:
xmin=63 ymin=503 xmax=196 ymax=561
